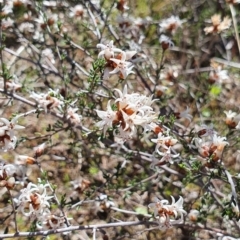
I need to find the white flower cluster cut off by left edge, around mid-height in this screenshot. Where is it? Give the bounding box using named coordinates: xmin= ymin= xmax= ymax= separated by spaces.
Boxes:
xmin=0 ymin=116 xmax=25 ymax=151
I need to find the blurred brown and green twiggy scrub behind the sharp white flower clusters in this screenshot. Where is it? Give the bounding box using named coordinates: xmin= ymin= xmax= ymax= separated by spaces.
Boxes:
xmin=0 ymin=0 xmax=240 ymax=240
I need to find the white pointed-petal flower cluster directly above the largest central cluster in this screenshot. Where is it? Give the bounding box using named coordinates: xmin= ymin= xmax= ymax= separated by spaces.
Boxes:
xmin=97 ymin=41 xmax=136 ymax=79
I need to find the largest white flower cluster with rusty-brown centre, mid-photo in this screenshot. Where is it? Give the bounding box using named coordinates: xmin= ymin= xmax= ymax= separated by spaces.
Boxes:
xmin=96 ymin=86 xmax=157 ymax=140
